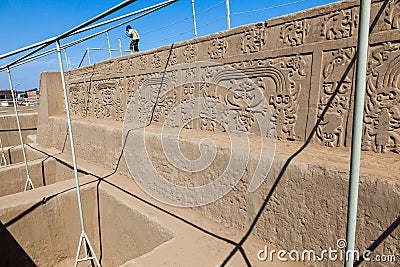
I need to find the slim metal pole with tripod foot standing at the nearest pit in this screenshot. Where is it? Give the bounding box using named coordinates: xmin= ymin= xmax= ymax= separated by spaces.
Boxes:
xmin=56 ymin=40 xmax=101 ymax=267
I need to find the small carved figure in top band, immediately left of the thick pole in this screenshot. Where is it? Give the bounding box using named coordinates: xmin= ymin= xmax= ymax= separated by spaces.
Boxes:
xmin=321 ymin=9 xmax=358 ymax=40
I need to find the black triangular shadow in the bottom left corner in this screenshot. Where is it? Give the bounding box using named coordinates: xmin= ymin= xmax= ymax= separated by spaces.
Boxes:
xmin=0 ymin=222 xmax=37 ymax=267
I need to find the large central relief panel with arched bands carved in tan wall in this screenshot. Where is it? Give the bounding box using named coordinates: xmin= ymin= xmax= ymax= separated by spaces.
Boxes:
xmin=147 ymin=55 xmax=310 ymax=140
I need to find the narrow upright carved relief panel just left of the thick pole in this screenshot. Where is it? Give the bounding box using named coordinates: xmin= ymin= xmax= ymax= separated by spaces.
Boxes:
xmin=317 ymin=47 xmax=355 ymax=147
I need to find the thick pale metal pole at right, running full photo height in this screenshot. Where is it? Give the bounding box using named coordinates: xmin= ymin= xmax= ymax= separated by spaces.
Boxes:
xmin=345 ymin=0 xmax=371 ymax=267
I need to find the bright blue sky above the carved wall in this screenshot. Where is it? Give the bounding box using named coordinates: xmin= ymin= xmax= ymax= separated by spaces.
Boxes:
xmin=0 ymin=0 xmax=335 ymax=90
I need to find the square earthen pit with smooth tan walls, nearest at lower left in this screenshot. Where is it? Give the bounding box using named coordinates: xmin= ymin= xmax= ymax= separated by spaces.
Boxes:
xmin=0 ymin=181 xmax=173 ymax=267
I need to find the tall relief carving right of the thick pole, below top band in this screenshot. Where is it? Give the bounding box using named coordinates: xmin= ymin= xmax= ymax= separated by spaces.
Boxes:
xmin=362 ymin=43 xmax=400 ymax=153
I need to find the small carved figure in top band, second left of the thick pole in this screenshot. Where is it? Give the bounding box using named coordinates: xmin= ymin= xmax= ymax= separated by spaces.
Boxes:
xmin=280 ymin=20 xmax=309 ymax=46
